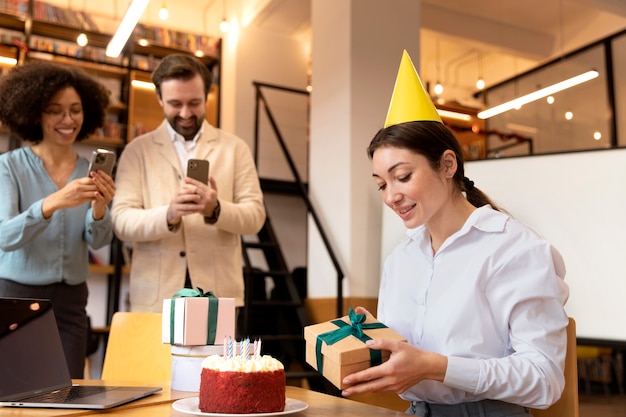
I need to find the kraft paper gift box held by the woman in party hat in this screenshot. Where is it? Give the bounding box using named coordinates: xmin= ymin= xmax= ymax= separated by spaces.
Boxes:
xmin=304 ymin=309 xmax=406 ymax=389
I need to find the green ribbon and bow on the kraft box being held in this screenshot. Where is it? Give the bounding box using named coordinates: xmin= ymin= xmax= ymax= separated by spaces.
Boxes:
xmin=315 ymin=307 xmax=387 ymax=374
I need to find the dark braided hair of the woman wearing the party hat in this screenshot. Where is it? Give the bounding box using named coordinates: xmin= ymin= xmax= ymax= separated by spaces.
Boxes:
xmin=367 ymin=121 xmax=503 ymax=211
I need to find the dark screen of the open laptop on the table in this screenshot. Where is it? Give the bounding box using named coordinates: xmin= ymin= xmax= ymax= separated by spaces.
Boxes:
xmin=0 ymin=298 xmax=72 ymax=401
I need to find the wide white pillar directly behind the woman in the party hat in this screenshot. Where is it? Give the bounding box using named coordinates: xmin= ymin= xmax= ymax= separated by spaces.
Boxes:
xmin=308 ymin=0 xmax=419 ymax=298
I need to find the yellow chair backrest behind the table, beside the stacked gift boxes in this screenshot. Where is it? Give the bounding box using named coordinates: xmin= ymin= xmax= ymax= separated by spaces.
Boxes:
xmin=102 ymin=312 xmax=172 ymax=385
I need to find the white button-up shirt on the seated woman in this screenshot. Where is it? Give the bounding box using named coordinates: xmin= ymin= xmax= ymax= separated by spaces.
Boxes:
xmin=378 ymin=206 xmax=569 ymax=408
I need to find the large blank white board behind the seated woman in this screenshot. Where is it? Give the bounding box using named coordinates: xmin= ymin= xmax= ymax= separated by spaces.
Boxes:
xmin=465 ymin=149 xmax=626 ymax=343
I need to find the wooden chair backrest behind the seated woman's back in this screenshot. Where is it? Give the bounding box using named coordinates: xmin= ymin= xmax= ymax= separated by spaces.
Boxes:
xmin=531 ymin=317 xmax=579 ymax=417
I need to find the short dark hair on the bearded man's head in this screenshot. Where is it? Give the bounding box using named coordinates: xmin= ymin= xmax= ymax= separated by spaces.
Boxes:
xmin=152 ymin=54 xmax=213 ymax=98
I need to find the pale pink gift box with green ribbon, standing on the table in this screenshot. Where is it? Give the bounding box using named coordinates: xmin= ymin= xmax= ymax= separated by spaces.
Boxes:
xmin=162 ymin=288 xmax=235 ymax=346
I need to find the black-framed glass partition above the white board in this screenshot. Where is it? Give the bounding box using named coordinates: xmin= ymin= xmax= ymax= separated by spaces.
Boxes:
xmin=484 ymin=35 xmax=626 ymax=158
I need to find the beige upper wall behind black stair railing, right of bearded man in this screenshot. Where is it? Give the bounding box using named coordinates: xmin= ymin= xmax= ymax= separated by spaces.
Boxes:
xmin=233 ymin=28 xmax=308 ymax=181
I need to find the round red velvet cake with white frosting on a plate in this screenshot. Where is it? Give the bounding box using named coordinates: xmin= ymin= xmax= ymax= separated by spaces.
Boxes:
xmin=198 ymin=355 xmax=285 ymax=414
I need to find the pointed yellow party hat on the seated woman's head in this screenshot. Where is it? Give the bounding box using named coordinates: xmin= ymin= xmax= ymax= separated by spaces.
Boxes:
xmin=385 ymin=50 xmax=443 ymax=127
